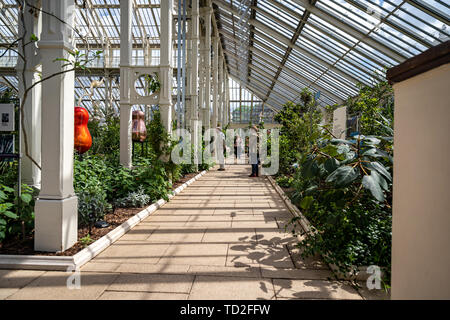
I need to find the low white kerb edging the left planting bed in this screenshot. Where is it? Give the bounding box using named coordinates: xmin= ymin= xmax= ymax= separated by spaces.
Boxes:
xmin=0 ymin=170 xmax=207 ymax=271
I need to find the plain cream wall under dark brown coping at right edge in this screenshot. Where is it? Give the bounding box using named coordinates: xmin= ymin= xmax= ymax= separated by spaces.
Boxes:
xmin=392 ymin=64 xmax=450 ymax=299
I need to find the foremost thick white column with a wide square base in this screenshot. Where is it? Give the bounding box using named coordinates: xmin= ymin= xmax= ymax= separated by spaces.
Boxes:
xmin=34 ymin=0 xmax=78 ymax=252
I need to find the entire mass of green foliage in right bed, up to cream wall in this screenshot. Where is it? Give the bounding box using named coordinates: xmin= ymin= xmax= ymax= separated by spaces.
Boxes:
xmin=277 ymin=84 xmax=393 ymax=285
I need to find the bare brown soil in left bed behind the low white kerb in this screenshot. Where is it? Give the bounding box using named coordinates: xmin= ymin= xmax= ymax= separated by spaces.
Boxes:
xmin=0 ymin=173 xmax=198 ymax=256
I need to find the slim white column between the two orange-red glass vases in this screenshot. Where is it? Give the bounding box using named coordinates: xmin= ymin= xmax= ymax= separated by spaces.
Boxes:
xmin=120 ymin=1 xmax=134 ymax=168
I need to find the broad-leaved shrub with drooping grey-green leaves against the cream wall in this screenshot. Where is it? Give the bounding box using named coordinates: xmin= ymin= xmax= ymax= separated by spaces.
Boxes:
xmin=292 ymin=132 xmax=392 ymax=280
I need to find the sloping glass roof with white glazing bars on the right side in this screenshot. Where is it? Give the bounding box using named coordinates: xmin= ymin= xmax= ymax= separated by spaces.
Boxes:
xmin=213 ymin=0 xmax=450 ymax=108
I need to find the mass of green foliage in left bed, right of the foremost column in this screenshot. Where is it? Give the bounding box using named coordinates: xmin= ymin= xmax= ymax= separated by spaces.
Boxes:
xmin=74 ymin=106 xmax=202 ymax=231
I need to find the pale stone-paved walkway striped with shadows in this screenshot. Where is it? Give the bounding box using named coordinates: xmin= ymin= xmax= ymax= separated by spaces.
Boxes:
xmin=0 ymin=165 xmax=383 ymax=300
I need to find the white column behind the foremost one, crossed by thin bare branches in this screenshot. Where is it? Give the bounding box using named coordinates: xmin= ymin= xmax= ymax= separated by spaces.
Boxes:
xmin=16 ymin=0 xmax=42 ymax=188
